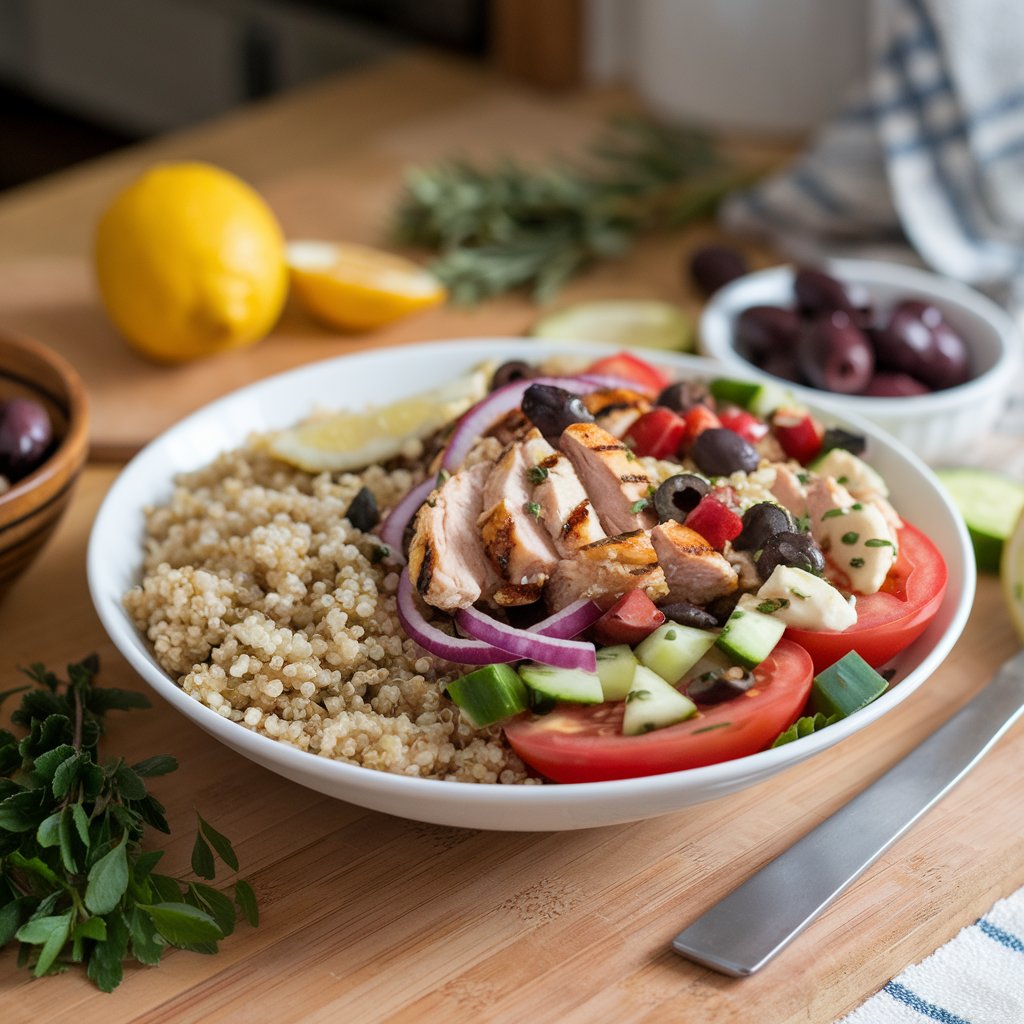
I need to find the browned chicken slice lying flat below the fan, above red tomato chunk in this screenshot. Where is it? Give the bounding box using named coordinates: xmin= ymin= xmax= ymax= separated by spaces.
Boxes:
xmin=545 ymin=529 xmax=669 ymax=611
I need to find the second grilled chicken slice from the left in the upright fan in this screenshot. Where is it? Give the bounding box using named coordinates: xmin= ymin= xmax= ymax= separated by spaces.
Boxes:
xmin=478 ymin=442 xmax=558 ymax=605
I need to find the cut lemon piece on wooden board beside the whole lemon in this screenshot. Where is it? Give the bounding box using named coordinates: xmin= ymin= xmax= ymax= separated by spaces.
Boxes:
xmin=286 ymin=241 xmax=447 ymax=331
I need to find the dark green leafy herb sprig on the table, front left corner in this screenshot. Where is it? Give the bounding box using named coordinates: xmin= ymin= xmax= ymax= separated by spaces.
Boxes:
xmin=0 ymin=655 xmax=259 ymax=992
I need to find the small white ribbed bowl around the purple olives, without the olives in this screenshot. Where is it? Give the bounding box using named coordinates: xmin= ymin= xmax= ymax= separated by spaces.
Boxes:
xmin=699 ymin=260 xmax=1021 ymax=464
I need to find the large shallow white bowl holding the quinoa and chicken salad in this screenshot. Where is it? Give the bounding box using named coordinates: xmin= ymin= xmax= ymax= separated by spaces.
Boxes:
xmin=88 ymin=338 xmax=975 ymax=830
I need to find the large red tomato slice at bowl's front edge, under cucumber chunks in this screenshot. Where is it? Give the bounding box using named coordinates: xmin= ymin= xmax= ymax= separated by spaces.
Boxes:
xmin=505 ymin=639 xmax=812 ymax=782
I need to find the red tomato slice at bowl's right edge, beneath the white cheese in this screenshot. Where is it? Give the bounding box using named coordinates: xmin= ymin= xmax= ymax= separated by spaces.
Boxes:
xmin=785 ymin=521 xmax=948 ymax=672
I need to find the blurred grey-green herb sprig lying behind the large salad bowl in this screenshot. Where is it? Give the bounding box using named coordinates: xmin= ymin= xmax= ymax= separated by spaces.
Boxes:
xmin=393 ymin=118 xmax=752 ymax=304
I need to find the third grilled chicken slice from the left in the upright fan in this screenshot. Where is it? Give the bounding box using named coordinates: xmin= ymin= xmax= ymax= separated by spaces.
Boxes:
xmin=523 ymin=430 xmax=606 ymax=558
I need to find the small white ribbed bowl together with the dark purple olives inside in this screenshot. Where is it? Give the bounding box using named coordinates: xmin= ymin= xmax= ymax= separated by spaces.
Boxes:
xmin=700 ymin=260 xmax=1021 ymax=463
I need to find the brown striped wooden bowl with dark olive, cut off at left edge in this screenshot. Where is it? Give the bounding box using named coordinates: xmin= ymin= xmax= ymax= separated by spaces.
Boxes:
xmin=0 ymin=336 xmax=88 ymax=595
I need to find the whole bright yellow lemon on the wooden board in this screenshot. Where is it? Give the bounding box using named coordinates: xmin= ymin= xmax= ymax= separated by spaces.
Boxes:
xmin=95 ymin=163 xmax=288 ymax=362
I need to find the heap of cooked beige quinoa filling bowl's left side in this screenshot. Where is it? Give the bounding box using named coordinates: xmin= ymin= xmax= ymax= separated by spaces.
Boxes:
xmin=124 ymin=439 xmax=537 ymax=783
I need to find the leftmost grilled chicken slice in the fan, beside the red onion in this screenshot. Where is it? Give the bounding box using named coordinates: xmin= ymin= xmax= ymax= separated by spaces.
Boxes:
xmin=409 ymin=464 xmax=494 ymax=611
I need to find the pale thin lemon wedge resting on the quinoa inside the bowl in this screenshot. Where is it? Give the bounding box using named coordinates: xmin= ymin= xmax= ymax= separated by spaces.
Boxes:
xmin=256 ymin=366 xmax=494 ymax=473
